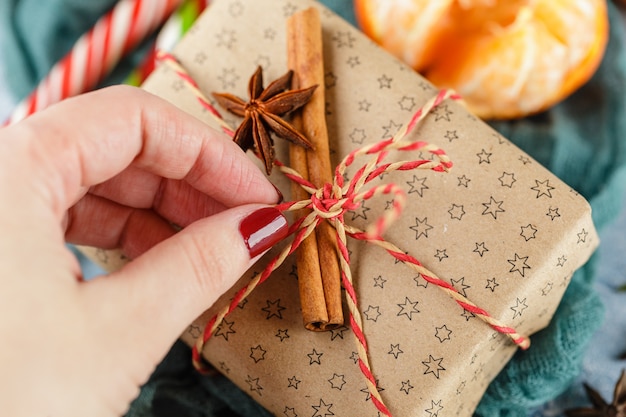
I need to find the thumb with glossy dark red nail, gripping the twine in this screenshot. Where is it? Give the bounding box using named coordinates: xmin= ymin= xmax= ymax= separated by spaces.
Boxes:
xmin=81 ymin=204 xmax=288 ymax=366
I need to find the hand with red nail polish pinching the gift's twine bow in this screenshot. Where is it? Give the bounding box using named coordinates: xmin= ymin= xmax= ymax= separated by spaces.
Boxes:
xmin=0 ymin=87 xmax=287 ymax=417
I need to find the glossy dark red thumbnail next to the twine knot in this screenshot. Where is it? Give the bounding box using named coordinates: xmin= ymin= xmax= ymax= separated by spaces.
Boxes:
xmin=239 ymin=207 xmax=289 ymax=258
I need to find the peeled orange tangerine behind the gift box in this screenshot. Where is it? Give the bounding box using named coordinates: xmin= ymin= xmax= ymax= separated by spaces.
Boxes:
xmin=354 ymin=0 xmax=608 ymax=119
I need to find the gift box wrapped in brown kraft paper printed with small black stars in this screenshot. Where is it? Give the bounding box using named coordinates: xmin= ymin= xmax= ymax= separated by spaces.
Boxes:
xmin=80 ymin=0 xmax=598 ymax=417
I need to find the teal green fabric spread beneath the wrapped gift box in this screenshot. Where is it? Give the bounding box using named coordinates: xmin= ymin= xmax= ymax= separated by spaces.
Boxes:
xmin=0 ymin=0 xmax=626 ymax=417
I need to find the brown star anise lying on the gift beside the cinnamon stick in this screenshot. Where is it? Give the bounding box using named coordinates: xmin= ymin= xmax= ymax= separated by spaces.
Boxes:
xmin=212 ymin=66 xmax=317 ymax=175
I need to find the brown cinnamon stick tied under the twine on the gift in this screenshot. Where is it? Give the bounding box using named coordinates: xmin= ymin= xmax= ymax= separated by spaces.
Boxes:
xmin=287 ymin=7 xmax=343 ymax=330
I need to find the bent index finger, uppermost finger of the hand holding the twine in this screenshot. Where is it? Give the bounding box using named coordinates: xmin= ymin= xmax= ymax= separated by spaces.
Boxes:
xmin=3 ymin=86 xmax=278 ymax=219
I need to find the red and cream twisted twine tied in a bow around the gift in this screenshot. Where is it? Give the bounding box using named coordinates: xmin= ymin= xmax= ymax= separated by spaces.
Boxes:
xmin=158 ymin=53 xmax=530 ymax=416
